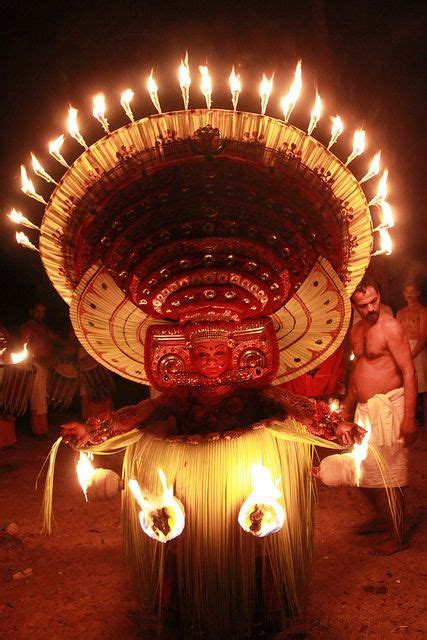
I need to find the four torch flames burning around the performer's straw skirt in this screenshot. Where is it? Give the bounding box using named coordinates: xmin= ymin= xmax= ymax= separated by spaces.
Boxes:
xmin=77 ymin=423 xmax=371 ymax=542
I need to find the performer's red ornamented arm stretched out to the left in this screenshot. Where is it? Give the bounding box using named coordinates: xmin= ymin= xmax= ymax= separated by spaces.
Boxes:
xmin=61 ymin=396 xmax=176 ymax=447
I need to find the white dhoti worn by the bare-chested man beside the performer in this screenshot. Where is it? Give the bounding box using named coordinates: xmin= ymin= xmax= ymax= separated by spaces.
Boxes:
xmin=354 ymin=387 xmax=408 ymax=488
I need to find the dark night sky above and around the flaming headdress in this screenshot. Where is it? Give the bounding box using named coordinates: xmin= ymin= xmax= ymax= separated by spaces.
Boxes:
xmin=0 ymin=0 xmax=427 ymax=326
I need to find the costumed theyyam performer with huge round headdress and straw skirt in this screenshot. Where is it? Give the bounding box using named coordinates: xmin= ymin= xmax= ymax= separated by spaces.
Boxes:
xmin=10 ymin=59 xmax=398 ymax=639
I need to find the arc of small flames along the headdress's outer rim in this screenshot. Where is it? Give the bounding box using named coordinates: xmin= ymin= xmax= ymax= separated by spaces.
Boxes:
xmin=9 ymin=54 xmax=394 ymax=255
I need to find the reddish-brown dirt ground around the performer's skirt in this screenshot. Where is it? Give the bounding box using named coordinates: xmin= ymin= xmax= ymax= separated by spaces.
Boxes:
xmin=0 ymin=416 xmax=427 ymax=640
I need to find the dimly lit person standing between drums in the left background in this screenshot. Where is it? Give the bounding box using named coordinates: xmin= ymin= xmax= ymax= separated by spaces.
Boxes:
xmin=20 ymin=302 xmax=64 ymax=438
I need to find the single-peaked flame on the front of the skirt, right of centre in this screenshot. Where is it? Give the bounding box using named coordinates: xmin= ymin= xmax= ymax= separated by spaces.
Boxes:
xmin=238 ymin=464 xmax=285 ymax=538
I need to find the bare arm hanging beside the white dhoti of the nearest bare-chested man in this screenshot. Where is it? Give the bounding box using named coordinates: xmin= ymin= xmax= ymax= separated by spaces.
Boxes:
xmin=386 ymin=323 xmax=417 ymax=444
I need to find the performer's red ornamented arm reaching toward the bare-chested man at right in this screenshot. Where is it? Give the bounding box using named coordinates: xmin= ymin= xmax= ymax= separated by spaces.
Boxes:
xmin=262 ymin=387 xmax=365 ymax=445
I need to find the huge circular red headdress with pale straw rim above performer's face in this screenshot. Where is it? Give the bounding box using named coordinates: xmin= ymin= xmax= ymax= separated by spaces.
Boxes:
xmin=10 ymin=61 xmax=388 ymax=386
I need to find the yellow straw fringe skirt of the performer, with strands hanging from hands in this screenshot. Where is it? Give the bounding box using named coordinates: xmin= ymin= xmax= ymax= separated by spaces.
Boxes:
xmin=39 ymin=418 xmax=399 ymax=640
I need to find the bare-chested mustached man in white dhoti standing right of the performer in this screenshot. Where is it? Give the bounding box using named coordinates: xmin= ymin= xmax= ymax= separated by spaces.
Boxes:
xmin=343 ymin=281 xmax=417 ymax=555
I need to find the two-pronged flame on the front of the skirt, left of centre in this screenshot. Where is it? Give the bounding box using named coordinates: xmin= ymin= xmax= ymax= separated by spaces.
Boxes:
xmin=129 ymin=469 xmax=185 ymax=542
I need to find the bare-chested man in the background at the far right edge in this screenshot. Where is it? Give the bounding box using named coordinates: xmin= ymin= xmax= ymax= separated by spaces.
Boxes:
xmin=397 ymin=284 xmax=427 ymax=427
